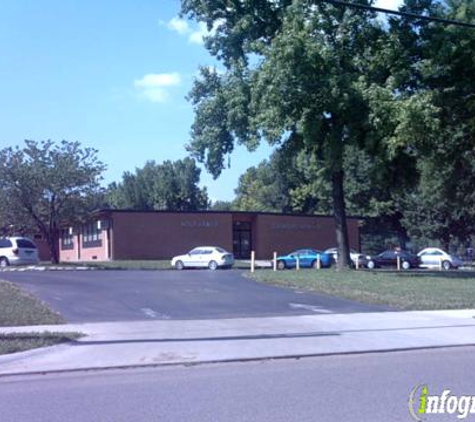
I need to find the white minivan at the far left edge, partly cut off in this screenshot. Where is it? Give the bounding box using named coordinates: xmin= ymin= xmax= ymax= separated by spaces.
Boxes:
xmin=0 ymin=237 xmax=40 ymax=268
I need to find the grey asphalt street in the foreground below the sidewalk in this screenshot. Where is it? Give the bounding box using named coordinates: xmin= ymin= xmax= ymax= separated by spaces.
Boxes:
xmin=0 ymin=347 xmax=475 ymax=422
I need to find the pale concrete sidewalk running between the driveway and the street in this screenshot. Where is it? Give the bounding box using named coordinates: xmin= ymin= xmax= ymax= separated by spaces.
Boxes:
xmin=0 ymin=310 xmax=475 ymax=376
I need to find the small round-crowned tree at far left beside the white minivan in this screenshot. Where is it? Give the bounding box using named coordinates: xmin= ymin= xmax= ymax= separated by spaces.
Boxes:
xmin=0 ymin=140 xmax=105 ymax=263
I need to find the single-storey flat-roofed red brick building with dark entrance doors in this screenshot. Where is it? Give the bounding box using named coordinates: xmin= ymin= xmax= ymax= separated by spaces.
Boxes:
xmin=60 ymin=210 xmax=360 ymax=261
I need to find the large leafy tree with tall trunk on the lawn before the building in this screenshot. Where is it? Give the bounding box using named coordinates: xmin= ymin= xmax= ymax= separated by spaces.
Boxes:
xmin=182 ymin=0 xmax=431 ymax=267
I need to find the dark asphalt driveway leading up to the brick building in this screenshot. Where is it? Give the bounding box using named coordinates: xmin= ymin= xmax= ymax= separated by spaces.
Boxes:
xmin=0 ymin=270 xmax=388 ymax=323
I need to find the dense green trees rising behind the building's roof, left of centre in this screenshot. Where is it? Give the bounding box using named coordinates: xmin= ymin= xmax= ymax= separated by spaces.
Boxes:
xmin=107 ymin=158 xmax=209 ymax=211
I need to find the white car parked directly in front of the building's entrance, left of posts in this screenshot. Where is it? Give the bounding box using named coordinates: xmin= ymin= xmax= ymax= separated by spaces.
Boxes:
xmin=171 ymin=246 xmax=234 ymax=270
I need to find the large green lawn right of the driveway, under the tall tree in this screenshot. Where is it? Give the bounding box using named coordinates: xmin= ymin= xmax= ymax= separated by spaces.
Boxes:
xmin=245 ymin=269 xmax=475 ymax=310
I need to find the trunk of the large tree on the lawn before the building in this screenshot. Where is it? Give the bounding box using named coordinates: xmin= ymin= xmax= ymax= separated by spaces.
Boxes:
xmin=332 ymin=170 xmax=351 ymax=270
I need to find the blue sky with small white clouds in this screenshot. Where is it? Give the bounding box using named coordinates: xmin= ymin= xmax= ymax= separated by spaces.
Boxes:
xmin=0 ymin=0 xmax=398 ymax=204
